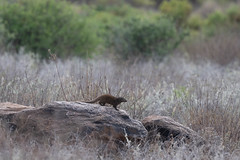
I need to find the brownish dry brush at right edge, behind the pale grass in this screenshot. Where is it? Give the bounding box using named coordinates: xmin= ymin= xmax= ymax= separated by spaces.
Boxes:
xmin=185 ymin=31 xmax=240 ymax=65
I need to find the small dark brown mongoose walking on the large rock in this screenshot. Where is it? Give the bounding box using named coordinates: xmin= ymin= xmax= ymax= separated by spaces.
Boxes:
xmin=86 ymin=94 xmax=127 ymax=111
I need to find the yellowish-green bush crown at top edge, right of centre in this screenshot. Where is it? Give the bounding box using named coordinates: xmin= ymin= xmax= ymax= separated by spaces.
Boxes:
xmin=160 ymin=0 xmax=192 ymax=25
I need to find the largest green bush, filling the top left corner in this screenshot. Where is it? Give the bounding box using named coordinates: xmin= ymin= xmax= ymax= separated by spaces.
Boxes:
xmin=0 ymin=0 xmax=97 ymax=57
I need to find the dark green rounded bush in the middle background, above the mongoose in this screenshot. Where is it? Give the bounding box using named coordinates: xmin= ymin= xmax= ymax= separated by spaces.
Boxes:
xmin=109 ymin=17 xmax=183 ymax=59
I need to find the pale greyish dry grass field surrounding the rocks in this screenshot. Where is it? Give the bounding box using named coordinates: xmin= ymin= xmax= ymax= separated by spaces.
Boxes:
xmin=0 ymin=49 xmax=240 ymax=159
